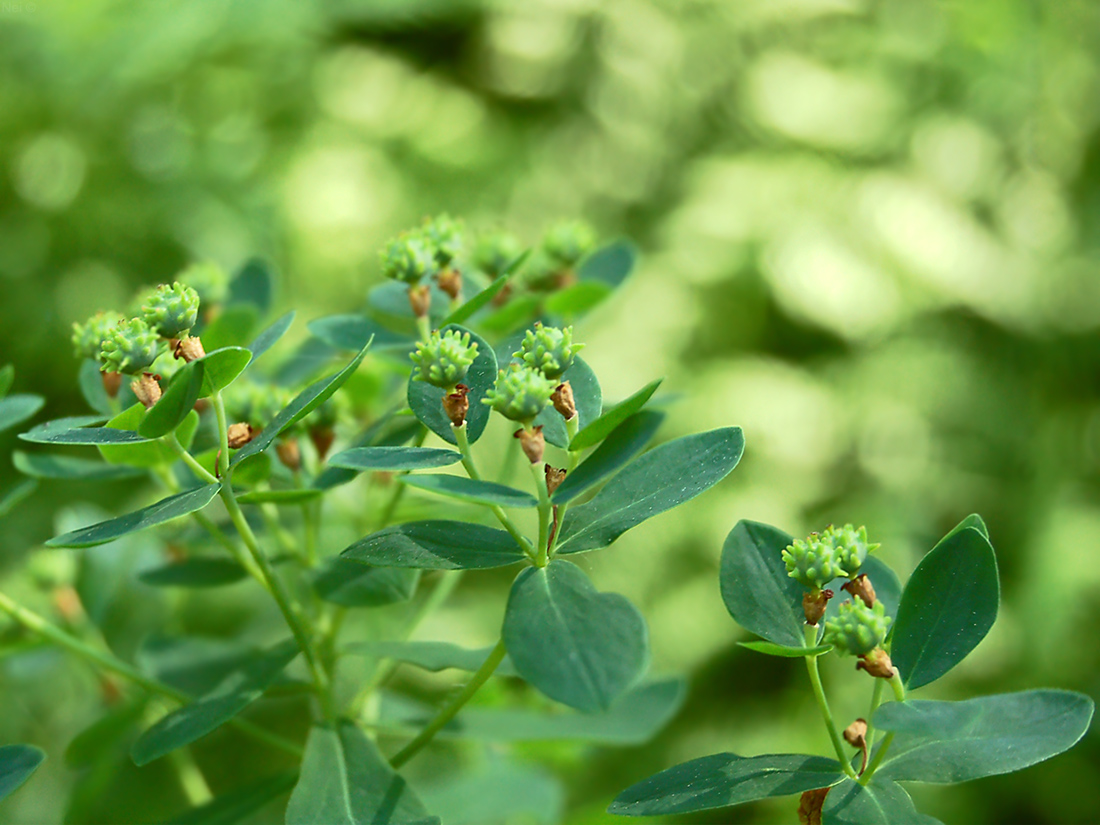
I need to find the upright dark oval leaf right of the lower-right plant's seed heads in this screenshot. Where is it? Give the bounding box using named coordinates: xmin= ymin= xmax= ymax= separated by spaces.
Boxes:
xmin=890 ymin=527 xmax=1001 ymax=690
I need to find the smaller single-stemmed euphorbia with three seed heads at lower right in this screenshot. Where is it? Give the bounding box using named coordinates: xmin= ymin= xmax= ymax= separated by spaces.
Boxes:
xmin=609 ymin=515 xmax=1093 ymax=825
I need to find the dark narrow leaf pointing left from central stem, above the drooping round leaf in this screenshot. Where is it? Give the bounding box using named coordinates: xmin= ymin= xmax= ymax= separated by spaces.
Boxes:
xmin=341 ymin=520 xmax=527 ymax=570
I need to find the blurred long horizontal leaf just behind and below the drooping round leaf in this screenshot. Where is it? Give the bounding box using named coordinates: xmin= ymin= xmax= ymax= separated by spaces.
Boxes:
xmin=380 ymin=682 xmax=688 ymax=745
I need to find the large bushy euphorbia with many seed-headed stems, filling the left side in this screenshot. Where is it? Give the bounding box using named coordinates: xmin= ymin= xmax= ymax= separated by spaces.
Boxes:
xmin=0 ymin=217 xmax=744 ymax=824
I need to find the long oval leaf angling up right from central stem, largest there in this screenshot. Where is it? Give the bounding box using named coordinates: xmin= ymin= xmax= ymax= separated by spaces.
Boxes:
xmin=558 ymin=427 xmax=745 ymax=553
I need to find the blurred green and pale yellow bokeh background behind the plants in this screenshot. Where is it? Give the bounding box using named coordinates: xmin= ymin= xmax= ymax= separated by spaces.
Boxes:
xmin=0 ymin=0 xmax=1100 ymax=824
